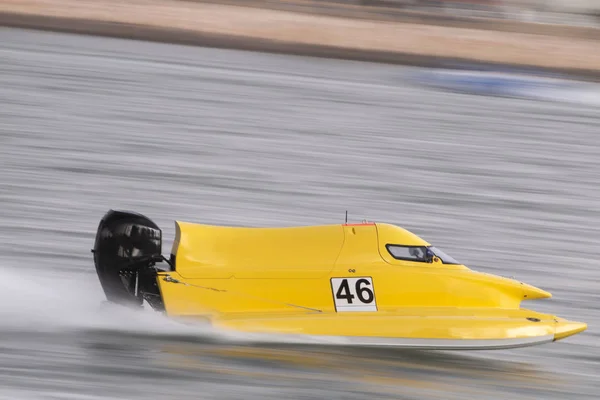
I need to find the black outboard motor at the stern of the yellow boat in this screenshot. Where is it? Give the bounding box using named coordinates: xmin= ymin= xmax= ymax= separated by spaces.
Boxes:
xmin=92 ymin=210 xmax=163 ymax=309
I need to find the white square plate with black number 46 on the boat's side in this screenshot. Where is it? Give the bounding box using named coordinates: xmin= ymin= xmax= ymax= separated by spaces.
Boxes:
xmin=331 ymin=276 xmax=377 ymax=312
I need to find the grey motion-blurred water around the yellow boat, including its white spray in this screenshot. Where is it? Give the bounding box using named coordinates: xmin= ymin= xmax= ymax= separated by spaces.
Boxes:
xmin=0 ymin=29 xmax=600 ymax=400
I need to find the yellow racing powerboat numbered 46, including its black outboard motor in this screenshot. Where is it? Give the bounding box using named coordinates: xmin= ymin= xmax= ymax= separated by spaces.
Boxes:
xmin=92 ymin=210 xmax=587 ymax=349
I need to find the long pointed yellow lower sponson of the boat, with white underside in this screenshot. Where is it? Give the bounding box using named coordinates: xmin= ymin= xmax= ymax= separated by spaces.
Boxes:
xmin=213 ymin=308 xmax=587 ymax=350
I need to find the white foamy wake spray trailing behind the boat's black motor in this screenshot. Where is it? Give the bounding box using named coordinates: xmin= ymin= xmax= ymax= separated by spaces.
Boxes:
xmin=0 ymin=268 xmax=211 ymax=335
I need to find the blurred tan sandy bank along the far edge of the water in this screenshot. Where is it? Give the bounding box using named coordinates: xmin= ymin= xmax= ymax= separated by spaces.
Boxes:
xmin=0 ymin=0 xmax=600 ymax=80
